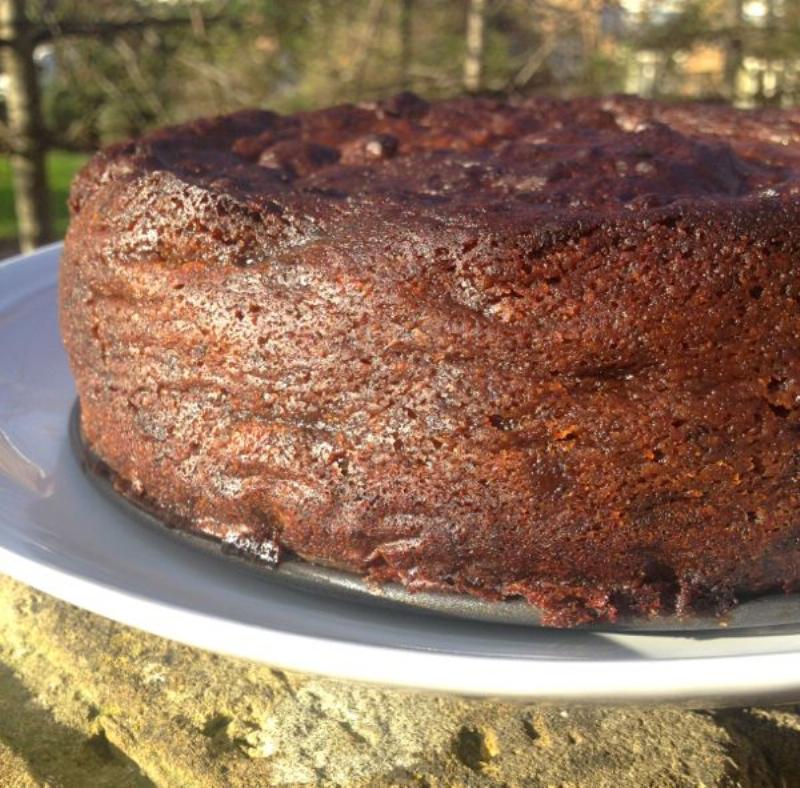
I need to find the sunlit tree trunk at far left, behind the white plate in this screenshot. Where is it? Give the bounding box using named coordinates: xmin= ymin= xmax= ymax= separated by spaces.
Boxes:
xmin=0 ymin=0 xmax=53 ymax=252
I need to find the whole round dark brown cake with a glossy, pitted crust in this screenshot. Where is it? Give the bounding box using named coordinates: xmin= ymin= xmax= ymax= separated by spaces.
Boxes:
xmin=61 ymin=94 xmax=800 ymax=625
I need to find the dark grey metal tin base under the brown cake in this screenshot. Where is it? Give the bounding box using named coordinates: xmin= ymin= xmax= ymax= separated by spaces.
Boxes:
xmin=69 ymin=400 xmax=800 ymax=635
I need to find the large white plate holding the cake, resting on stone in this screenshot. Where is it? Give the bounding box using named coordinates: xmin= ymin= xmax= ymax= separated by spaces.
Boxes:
xmin=0 ymin=246 xmax=800 ymax=705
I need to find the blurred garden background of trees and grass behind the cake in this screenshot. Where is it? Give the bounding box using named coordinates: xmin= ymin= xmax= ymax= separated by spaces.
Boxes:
xmin=0 ymin=0 xmax=800 ymax=254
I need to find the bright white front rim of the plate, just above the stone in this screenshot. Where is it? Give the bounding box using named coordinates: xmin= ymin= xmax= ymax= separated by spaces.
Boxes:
xmin=0 ymin=547 xmax=800 ymax=706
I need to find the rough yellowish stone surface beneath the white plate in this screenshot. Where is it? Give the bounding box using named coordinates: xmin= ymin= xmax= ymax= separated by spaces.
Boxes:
xmin=0 ymin=577 xmax=800 ymax=788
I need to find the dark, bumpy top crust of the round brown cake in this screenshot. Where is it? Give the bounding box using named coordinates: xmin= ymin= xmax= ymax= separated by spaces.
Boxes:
xmin=71 ymin=93 xmax=800 ymax=264
